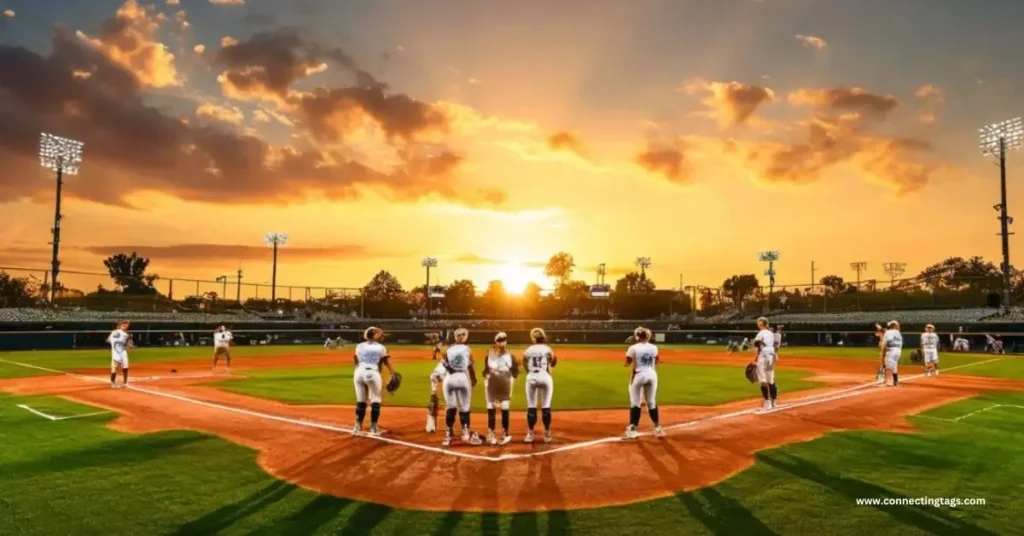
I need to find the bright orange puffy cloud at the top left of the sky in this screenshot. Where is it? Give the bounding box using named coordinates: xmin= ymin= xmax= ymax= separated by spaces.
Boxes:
xmin=77 ymin=0 xmax=181 ymax=87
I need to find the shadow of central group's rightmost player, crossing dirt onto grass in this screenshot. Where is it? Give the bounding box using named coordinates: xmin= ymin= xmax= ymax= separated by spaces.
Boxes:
xmin=637 ymin=441 xmax=776 ymax=535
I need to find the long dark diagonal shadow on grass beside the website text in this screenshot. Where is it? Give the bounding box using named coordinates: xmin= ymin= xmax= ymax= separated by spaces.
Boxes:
xmin=758 ymin=451 xmax=995 ymax=536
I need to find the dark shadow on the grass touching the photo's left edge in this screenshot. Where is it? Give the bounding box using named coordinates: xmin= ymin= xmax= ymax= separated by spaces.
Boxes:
xmin=0 ymin=431 xmax=212 ymax=477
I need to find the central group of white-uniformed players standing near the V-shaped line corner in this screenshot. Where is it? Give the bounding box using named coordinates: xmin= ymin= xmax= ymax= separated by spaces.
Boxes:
xmin=352 ymin=328 xmax=664 ymax=447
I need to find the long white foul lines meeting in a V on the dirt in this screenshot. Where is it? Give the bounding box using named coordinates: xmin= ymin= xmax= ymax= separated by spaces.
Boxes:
xmin=0 ymin=358 xmax=1006 ymax=461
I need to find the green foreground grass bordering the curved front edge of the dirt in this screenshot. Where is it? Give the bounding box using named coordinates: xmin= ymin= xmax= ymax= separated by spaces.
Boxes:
xmin=0 ymin=394 xmax=1024 ymax=535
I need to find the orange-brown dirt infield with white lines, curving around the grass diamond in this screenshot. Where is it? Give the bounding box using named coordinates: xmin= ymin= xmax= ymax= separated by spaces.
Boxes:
xmin=0 ymin=351 xmax=1024 ymax=512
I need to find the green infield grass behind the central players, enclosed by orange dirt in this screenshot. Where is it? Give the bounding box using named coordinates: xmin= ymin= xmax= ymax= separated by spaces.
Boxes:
xmin=207 ymin=360 xmax=823 ymax=411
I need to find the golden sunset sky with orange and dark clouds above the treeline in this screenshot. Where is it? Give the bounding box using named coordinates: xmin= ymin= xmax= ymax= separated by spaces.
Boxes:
xmin=0 ymin=0 xmax=1024 ymax=297
